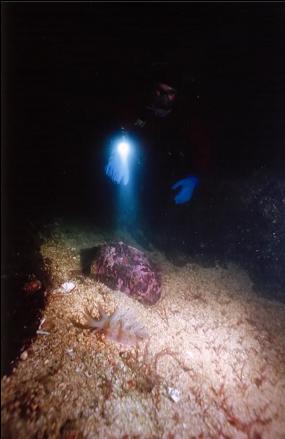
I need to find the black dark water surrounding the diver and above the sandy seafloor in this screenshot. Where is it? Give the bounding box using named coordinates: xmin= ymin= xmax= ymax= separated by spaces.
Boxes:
xmin=1 ymin=2 xmax=285 ymax=374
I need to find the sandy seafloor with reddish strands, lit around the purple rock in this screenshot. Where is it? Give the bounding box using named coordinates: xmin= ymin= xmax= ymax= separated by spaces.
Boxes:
xmin=2 ymin=222 xmax=285 ymax=439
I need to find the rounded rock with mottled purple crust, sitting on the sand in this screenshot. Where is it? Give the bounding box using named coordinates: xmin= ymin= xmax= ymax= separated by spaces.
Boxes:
xmin=90 ymin=242 xmax=161 ymax=305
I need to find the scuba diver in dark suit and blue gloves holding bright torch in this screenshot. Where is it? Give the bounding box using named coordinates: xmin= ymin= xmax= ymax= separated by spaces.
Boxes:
xmin=105 ymin=64 xmax=212 ymax=246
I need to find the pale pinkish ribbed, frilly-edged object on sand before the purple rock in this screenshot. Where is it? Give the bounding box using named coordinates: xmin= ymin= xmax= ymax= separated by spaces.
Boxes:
xmin=77 ymin=308 xmax=147 ymax=346
